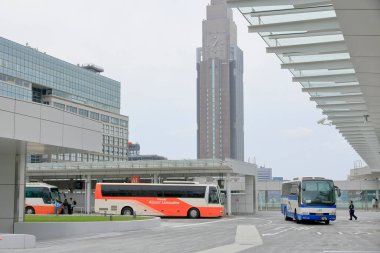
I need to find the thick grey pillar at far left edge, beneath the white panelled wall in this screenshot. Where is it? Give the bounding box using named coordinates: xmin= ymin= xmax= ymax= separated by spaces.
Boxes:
xmin=0 ymin=140 xmax=26 ymax=233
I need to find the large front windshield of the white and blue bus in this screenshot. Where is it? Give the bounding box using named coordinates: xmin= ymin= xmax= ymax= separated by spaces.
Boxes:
xmin=302 ymin=180 xmax=335 ymax=205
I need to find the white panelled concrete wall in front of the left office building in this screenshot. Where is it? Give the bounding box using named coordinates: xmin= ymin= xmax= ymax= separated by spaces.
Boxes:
xmin=0 ymin=97 xmax=103 ymax=152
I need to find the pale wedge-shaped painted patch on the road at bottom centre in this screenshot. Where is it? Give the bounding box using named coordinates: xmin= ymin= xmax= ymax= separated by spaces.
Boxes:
xmin=198 ymin=225 xmax=263 ymax=253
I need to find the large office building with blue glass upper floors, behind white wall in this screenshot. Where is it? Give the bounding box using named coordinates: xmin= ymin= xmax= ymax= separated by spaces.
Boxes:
xmin=0 ymin=37 xmax=128 ymax=162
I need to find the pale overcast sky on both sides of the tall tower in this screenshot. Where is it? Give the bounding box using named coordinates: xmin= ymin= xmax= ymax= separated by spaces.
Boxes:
xmin=0 ymin=0 xmax=360 ymax=179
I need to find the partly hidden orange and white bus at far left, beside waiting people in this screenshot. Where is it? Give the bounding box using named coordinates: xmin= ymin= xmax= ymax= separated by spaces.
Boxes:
xmin=25 ymin=183 xmax=62 ymax=214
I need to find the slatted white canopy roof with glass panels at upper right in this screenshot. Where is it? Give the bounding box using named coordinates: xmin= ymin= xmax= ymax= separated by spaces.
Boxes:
xmin=227 ymin=0 xmax=380 ymax=177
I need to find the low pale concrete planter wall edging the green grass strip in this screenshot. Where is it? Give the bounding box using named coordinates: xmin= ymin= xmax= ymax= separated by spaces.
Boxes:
xmin=14 ymin=217 xmax=161 ymax=240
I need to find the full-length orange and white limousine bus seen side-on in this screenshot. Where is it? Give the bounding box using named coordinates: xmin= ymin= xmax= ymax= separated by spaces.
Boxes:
xmin=95 ymin=183 xmax=224 ymax=218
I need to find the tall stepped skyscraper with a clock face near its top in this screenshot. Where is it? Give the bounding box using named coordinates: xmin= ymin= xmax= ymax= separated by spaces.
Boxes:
xmin=197 ymin=0 xmax=244 ymax=161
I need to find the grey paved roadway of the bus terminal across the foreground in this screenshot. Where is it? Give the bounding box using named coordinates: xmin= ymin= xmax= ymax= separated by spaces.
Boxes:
xmin=0 ymin=211 xmax=380 ymax=253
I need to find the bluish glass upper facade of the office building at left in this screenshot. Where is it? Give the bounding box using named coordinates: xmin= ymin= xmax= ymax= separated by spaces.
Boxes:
xmin=0 ymin=37 xmax=120 ymax=113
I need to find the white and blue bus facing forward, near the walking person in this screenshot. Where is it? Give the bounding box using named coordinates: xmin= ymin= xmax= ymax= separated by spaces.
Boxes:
xmin=281 ymin=177 xmax=340 ymax=224
